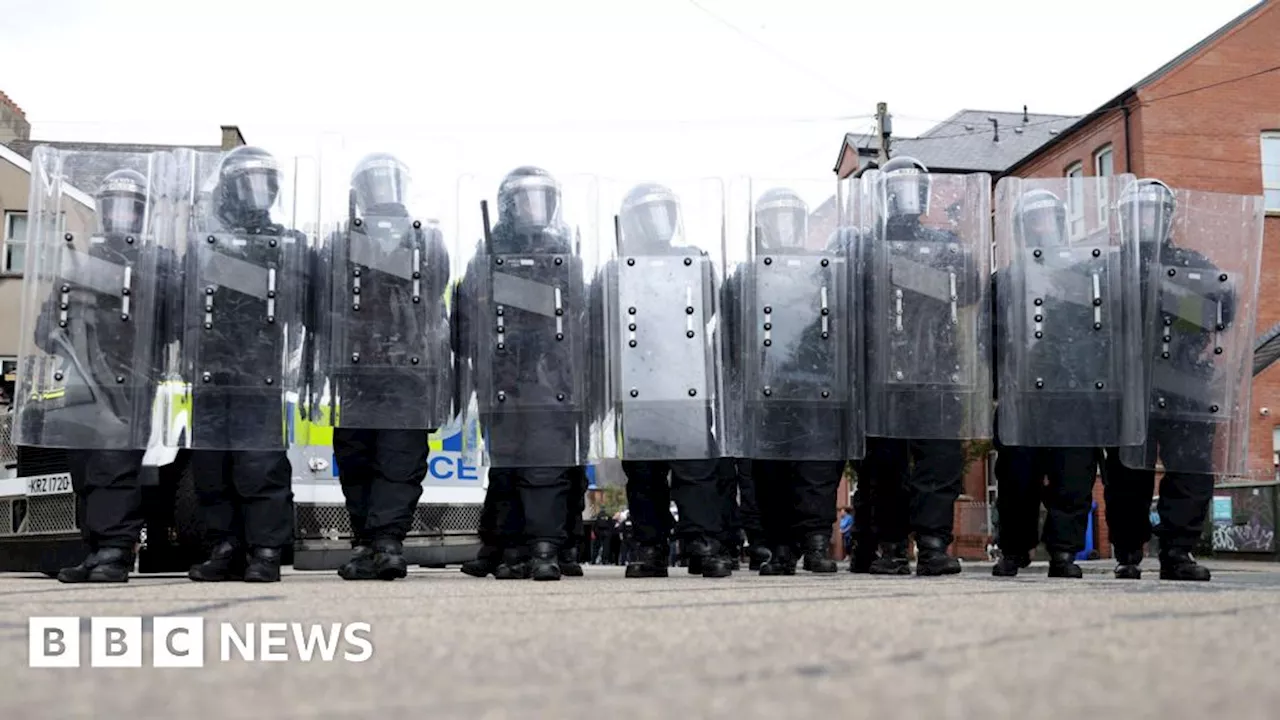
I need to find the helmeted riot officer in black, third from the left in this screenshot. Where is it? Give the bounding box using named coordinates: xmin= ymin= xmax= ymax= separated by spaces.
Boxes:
xmin=317 ymin=152 xmax=453 ymax=580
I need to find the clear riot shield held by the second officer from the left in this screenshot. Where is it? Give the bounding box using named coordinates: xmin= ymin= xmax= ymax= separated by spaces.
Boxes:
xmin=174 ymin=147 xmax=319 ymax=450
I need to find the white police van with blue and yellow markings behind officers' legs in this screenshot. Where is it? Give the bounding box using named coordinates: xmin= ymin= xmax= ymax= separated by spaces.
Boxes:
xmin=0 ymin=383 xmax=486 ymax=575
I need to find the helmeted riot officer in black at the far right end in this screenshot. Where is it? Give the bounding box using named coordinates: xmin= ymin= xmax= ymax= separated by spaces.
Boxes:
xmin=1102 ymin=179 xmax=1252 ymax=582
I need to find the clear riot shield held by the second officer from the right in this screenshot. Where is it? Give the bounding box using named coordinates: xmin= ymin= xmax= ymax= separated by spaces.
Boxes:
xmin=993 ymin=176 xmax=1146 ymax=447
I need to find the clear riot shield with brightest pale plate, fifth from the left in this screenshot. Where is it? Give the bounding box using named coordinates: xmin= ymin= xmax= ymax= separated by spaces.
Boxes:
xmin=589 ymin=178 xmax=726 ymax=460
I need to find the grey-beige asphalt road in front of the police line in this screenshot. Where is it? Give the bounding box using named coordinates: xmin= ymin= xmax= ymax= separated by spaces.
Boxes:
xmin=0 ymin=560 xmax=1280 ymax=720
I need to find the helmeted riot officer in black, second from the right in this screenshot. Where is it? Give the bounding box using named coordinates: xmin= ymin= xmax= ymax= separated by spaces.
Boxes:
xmin=992 ymin=185 xmax=1121 ymax=578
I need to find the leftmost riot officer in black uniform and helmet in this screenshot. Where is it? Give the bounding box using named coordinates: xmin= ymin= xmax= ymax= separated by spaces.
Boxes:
xmin=31 ymin=169 xmax=170 ymax=583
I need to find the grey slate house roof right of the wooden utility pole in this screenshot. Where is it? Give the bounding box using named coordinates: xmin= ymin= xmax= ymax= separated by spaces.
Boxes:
xmin=836 ymin=110 xmax=1079 ymax=173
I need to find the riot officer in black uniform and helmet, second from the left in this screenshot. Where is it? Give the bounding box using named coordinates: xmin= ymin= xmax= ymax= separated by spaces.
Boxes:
xmin=184 ymin=147 xmax=299 ymax=582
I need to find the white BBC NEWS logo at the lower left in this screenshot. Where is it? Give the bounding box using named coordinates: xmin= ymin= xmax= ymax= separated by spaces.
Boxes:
xmin=27 ymin=618 xmax=374 ymax=667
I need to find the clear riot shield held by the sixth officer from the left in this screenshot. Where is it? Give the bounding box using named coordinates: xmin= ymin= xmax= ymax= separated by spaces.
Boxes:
xmin=726 ymin=178 xmax=861 ymax=460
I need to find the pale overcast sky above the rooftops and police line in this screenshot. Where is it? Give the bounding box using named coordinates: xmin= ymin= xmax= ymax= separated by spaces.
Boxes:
xmin=0 ymin=0 xmax=1254 ymax=226
